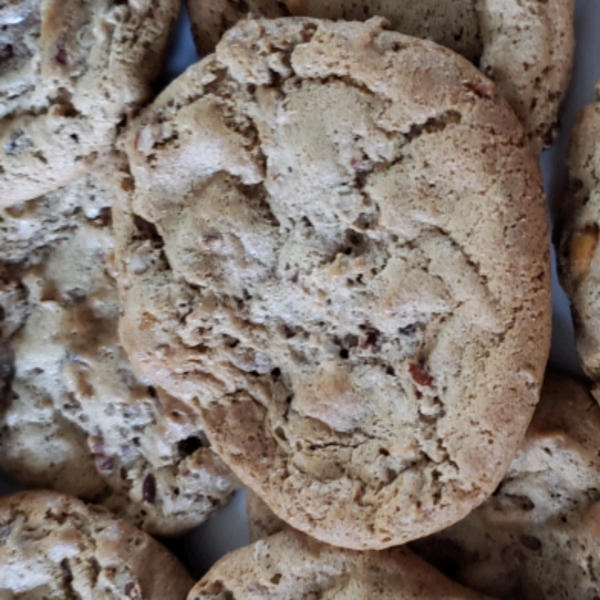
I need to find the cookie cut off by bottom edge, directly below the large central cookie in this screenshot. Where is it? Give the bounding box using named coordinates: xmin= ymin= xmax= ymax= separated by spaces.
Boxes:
xmin=188 ymin=529 xmax=492 ymax=600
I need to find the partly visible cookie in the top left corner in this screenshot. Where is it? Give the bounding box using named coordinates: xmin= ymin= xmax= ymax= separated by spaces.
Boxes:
xmin=0 ymin=0 xmax=179 ymax=206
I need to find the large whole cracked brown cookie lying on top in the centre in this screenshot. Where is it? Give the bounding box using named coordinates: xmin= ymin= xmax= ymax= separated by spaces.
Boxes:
xmin=115 ymin=18 xmax=550 ymax=549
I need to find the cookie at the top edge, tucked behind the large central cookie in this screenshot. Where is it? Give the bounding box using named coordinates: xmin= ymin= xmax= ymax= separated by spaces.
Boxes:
xmin=188 ymin=0 xmax=574 ymax=152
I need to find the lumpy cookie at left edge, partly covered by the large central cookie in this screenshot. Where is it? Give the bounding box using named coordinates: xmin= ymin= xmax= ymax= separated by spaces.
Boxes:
xmin=0 ymin=168 xmax=236 ymax=535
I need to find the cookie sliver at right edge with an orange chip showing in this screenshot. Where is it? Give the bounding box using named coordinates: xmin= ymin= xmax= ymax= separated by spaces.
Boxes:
xmin=554 ymin=85 xmax=600 ymax=392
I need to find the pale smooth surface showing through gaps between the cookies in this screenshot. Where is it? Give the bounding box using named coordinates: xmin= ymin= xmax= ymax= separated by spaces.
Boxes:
xmin=0 ymin=0 xmax=600 ymax=577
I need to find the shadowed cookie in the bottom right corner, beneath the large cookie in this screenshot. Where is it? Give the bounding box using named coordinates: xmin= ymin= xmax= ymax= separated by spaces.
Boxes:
xmin=413 ymin=375 xmax=600 ymax=600
